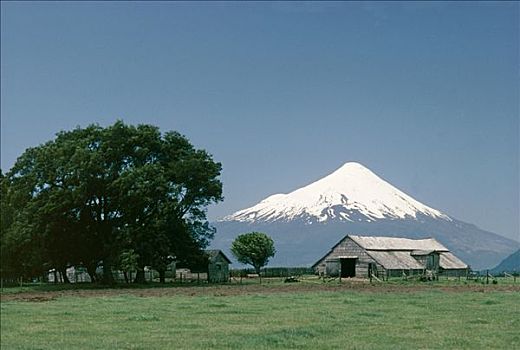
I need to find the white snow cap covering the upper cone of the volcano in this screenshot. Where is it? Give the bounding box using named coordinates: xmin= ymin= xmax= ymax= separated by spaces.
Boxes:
xmin=223 ymin=162 xmax=451 ymax=223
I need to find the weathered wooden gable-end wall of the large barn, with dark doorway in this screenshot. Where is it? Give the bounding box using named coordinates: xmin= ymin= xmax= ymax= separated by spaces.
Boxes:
xmin=315 ymin=237 xmax=383 ymax=278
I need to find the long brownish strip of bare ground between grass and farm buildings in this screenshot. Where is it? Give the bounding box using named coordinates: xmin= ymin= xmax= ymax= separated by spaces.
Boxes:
xmin=1 ymin=281 xmax=520 ymax=302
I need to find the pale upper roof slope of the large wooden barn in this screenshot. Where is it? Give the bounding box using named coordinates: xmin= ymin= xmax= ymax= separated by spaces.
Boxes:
xmin=348 ymin=235 xmax=449 ymax=255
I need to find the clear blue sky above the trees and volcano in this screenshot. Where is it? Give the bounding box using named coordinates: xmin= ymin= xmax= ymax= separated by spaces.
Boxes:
xmin=1 ymin=2 xmax=520 ymax=239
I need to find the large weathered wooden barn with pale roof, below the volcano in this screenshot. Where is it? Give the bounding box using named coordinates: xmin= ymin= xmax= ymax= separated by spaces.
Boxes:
xmin=313 ymin=235 xmax=468 ymax=278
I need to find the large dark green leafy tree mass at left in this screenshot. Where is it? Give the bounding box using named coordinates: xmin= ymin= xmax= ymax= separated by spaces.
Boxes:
xmin=0 ymin=121 xmax=223 ymax=283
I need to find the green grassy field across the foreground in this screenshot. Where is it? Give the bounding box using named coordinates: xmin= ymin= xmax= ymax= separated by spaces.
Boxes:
xmin=1 ymin=287 xmax=520 ymax=349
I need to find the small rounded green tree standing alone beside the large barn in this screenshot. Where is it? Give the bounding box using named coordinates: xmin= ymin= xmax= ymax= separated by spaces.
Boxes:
xmin=231 ymin=232 xmax=276 ymax=273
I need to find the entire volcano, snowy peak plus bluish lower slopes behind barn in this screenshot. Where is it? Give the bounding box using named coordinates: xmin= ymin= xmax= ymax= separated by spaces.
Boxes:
xmin=212 ymin=163 xmax=519 ymax=269
